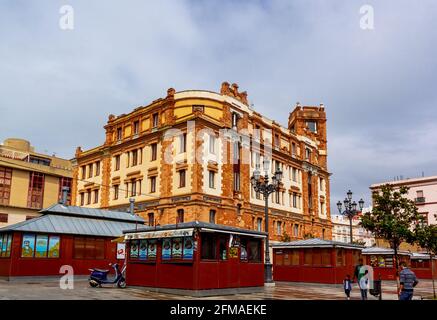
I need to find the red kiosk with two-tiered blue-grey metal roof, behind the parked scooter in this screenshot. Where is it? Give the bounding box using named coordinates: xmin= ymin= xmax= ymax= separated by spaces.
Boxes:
xmin=0 ymin=204 xmax=144 ymax=279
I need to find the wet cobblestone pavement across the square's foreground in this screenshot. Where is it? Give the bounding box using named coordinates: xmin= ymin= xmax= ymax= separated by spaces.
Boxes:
xmin=0 ymin=280 xmax=432 ymax=300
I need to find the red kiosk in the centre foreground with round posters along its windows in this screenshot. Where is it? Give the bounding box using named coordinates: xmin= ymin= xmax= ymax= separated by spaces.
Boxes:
xmin=125 ymin=221 xmax=266 ymax=296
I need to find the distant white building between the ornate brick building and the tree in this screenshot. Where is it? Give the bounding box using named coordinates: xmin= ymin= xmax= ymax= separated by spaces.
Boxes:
xmin=331 ymin=209 xmax=376 ymax=247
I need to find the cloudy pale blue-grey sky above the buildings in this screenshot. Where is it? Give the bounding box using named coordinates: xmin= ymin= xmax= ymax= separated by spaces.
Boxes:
xmin=0 ymin=0 xmax=437 ymax=213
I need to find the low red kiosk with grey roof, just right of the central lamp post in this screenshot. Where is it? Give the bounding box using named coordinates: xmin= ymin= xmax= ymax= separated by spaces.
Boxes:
xmin=272 ymin=238 xmax=363 ymax=284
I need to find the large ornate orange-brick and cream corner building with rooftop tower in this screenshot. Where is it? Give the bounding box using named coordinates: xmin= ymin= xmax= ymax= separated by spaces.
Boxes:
xmin=73 ymin=82 xmax=332 ymax=241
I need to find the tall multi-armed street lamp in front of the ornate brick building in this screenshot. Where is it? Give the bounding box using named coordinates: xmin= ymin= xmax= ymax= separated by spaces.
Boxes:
xmin=250 ymin=159 xmax=282 ymax=283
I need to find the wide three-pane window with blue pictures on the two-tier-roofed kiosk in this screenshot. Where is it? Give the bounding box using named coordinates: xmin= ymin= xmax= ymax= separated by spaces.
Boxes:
xmin=21 ymin=233 xmax=60 ymax=258
